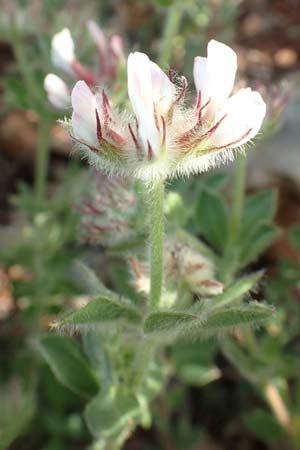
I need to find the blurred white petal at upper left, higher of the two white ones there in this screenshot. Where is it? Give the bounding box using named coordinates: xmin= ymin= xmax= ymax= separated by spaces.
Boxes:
xmin=51 ymin=28 xmax=76 ymax=75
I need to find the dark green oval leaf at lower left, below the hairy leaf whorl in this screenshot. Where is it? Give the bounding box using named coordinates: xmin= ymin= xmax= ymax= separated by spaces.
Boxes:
xmin=36 ymin=335 xmax=99 ymax=397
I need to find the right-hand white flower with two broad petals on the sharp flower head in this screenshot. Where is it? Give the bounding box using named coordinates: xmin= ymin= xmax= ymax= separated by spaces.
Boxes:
xmin=194 ymin=40 xmax=266 ymax=149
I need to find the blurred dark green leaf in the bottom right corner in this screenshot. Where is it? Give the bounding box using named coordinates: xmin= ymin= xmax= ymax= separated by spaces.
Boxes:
xmin=244 ymin=409 xmax=287 ymax=444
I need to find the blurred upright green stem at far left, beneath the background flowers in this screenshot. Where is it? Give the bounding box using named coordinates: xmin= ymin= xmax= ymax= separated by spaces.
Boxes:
xmin=35 ymin=117 xmax=50 ymax=204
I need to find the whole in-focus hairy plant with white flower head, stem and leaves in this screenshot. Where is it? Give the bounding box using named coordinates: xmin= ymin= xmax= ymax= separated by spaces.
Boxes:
xmin=38 ymin=37 xmax=273 ymax=450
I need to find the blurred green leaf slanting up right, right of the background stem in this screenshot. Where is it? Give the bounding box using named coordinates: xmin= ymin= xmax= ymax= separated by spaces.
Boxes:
xmin=239 ymin=224 xmax=279 ymax=267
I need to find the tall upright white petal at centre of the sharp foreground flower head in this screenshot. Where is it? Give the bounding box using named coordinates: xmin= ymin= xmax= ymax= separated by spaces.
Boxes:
xmin=127 ymin=52 xmax=160 ymax=153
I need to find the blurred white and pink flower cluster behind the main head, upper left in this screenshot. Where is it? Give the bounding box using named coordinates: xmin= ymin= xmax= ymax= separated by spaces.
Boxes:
xmin=44 ymin=21 xmax=124 ymax=109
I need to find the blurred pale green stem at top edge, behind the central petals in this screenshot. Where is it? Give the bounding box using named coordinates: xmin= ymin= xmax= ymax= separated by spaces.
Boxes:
xmin=158 ymin=1 xmax=184 ymax=67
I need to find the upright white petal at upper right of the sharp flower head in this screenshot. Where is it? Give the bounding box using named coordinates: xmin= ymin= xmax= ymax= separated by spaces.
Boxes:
xmin=194 ymin=40 xmax=237 ymax=105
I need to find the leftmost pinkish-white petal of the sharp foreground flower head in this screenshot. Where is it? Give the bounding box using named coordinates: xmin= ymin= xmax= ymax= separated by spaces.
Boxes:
xmin=71 ymin=81 xmax=99 ymax=146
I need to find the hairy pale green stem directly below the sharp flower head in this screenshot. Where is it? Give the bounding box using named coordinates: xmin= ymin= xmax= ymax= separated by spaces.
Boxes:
xmin=149 ymin=180 xmax=164 ymax=309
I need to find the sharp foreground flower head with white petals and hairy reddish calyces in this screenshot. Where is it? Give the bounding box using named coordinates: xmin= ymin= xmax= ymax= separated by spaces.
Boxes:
xmin=71 ymin=40 xmax=266 ymax=180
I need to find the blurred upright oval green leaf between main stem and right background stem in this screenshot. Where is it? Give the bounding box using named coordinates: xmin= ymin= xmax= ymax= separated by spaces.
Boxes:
xmin=196 ymin=189 xmax=228 ymax=250
